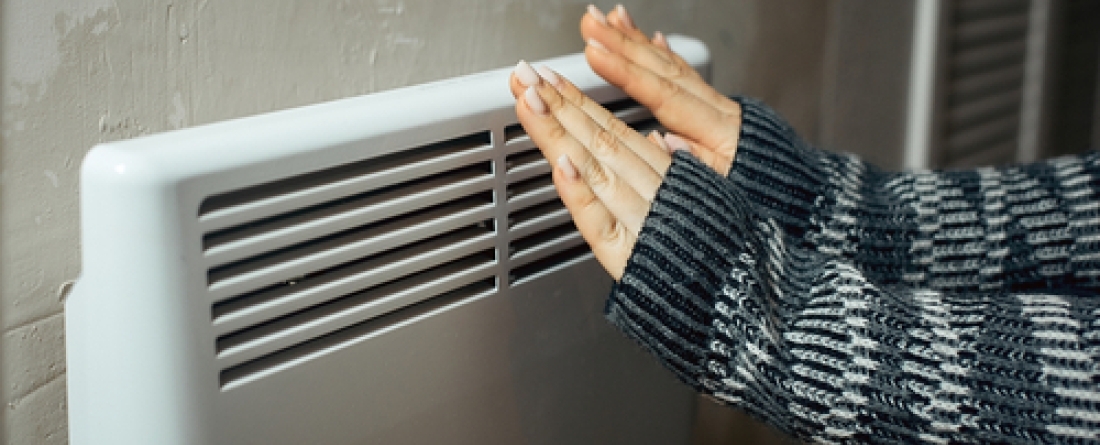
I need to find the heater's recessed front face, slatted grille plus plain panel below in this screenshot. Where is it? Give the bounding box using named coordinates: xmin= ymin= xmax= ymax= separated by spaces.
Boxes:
xmin=198 ymin=97 xmax=693 ymax=444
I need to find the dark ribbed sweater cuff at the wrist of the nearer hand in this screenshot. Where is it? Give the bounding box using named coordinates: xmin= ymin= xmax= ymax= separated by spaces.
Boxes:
xmin=606 ymin=152 xmax=758 ymax=390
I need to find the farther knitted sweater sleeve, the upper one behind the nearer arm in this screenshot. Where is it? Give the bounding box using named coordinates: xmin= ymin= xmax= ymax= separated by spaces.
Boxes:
xmin=729 ymin=98 xmax=1100 ymax=292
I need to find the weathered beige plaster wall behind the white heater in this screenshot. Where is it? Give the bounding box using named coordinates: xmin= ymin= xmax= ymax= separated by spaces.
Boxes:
xmin=0 ymin=0 xmax=833 ymax=444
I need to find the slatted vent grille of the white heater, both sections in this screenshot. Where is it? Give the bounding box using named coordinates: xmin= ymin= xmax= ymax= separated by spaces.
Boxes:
xmin=198 ymin=99 xmax=659 ymax=380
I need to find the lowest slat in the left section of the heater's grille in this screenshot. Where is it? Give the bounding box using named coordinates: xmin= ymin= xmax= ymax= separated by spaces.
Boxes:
xmin=220 ymin=278 xmax=496 ymax=390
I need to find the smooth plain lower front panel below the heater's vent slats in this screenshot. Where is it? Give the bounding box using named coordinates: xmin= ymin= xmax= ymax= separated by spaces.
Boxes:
xmin=218 ymin=260 xmax=694 ymax=445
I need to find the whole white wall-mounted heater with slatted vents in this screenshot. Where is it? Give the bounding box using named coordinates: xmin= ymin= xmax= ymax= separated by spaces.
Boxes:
xmin=66 ymin=37 xmax=708 ymax=445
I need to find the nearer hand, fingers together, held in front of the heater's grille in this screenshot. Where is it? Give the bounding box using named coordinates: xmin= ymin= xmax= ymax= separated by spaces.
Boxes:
xmin=510 ymin=62 xmax=671 ymax=280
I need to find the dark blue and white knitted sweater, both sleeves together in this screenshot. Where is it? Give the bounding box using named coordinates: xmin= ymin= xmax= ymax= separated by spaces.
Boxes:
xmin=607 ymin=99 xmax=1100 ymax=443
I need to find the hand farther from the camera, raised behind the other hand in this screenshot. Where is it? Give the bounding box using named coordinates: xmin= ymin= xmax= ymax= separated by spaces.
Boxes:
xmin=581 ymin=5 xmax=741 ymax=176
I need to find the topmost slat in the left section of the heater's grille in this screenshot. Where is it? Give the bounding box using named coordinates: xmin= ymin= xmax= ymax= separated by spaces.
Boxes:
xmin=199 ymin=131 xmax=493 ymax=232
